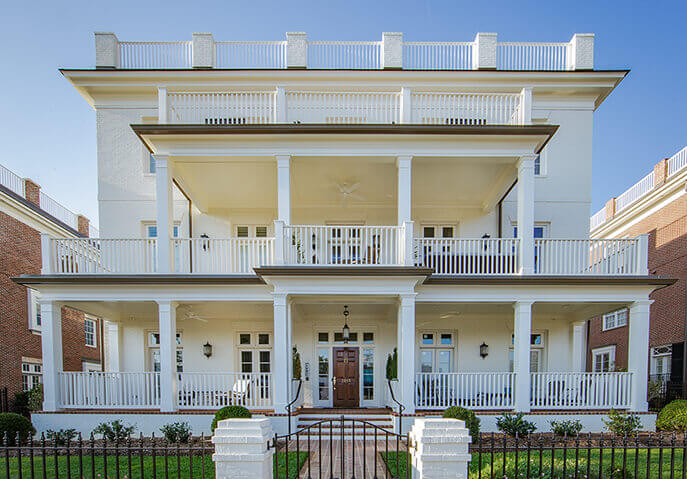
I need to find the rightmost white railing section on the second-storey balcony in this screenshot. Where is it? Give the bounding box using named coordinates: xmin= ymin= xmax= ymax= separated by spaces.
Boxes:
xmin=534 ymin=238 xmax=646 ymax=275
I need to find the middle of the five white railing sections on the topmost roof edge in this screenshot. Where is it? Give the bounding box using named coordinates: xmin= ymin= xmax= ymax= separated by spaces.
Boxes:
xmin=308 ymin=41 xmax=382 ymax=70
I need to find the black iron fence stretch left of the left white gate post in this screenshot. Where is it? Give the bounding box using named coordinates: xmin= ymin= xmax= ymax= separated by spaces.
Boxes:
xmin=0 ymin=434 xmax=215 ymax=479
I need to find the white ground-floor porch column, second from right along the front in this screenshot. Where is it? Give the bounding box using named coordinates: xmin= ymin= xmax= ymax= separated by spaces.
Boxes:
xmin=513 ymin=301 xmax=533 ymax=412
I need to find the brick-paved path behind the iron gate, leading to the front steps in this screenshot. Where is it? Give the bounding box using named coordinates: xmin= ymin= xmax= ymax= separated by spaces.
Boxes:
xmin=289 ymin=435 xmax=406 ymax=479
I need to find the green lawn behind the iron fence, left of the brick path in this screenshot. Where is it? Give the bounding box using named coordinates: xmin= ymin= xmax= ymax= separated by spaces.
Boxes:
xmin=0 ymin=451 xmax=308 ymax=479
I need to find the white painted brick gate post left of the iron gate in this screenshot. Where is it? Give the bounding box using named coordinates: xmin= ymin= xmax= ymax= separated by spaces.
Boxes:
xmin=212 ymin=418 xmax=274 ymax=479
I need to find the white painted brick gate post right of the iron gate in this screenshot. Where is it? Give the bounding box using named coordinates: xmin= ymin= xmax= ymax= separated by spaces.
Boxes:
xmin=410 ymin=418 xmax=472 ymax=479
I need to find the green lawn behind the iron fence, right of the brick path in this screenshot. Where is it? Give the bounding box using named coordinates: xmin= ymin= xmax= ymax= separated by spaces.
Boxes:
xmin=382 ymin=448 xmax=682 ymax=479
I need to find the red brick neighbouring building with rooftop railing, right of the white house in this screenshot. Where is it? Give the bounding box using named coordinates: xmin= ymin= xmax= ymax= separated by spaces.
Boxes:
xmin=587 ymin=148 xmax=687 ymax=392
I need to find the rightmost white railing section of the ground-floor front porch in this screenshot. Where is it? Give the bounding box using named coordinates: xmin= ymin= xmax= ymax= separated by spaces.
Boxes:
xmin=531 ymin=372 xmax=632 ymax=409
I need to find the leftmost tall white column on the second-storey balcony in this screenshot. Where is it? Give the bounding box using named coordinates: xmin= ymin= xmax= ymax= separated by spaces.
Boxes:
xmin=153 ymin=155 xmax=174 ymax=274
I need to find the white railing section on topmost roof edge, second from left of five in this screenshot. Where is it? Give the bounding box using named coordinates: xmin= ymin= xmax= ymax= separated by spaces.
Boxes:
xmin=215 ymin=41 xmax=286 ymax=68
